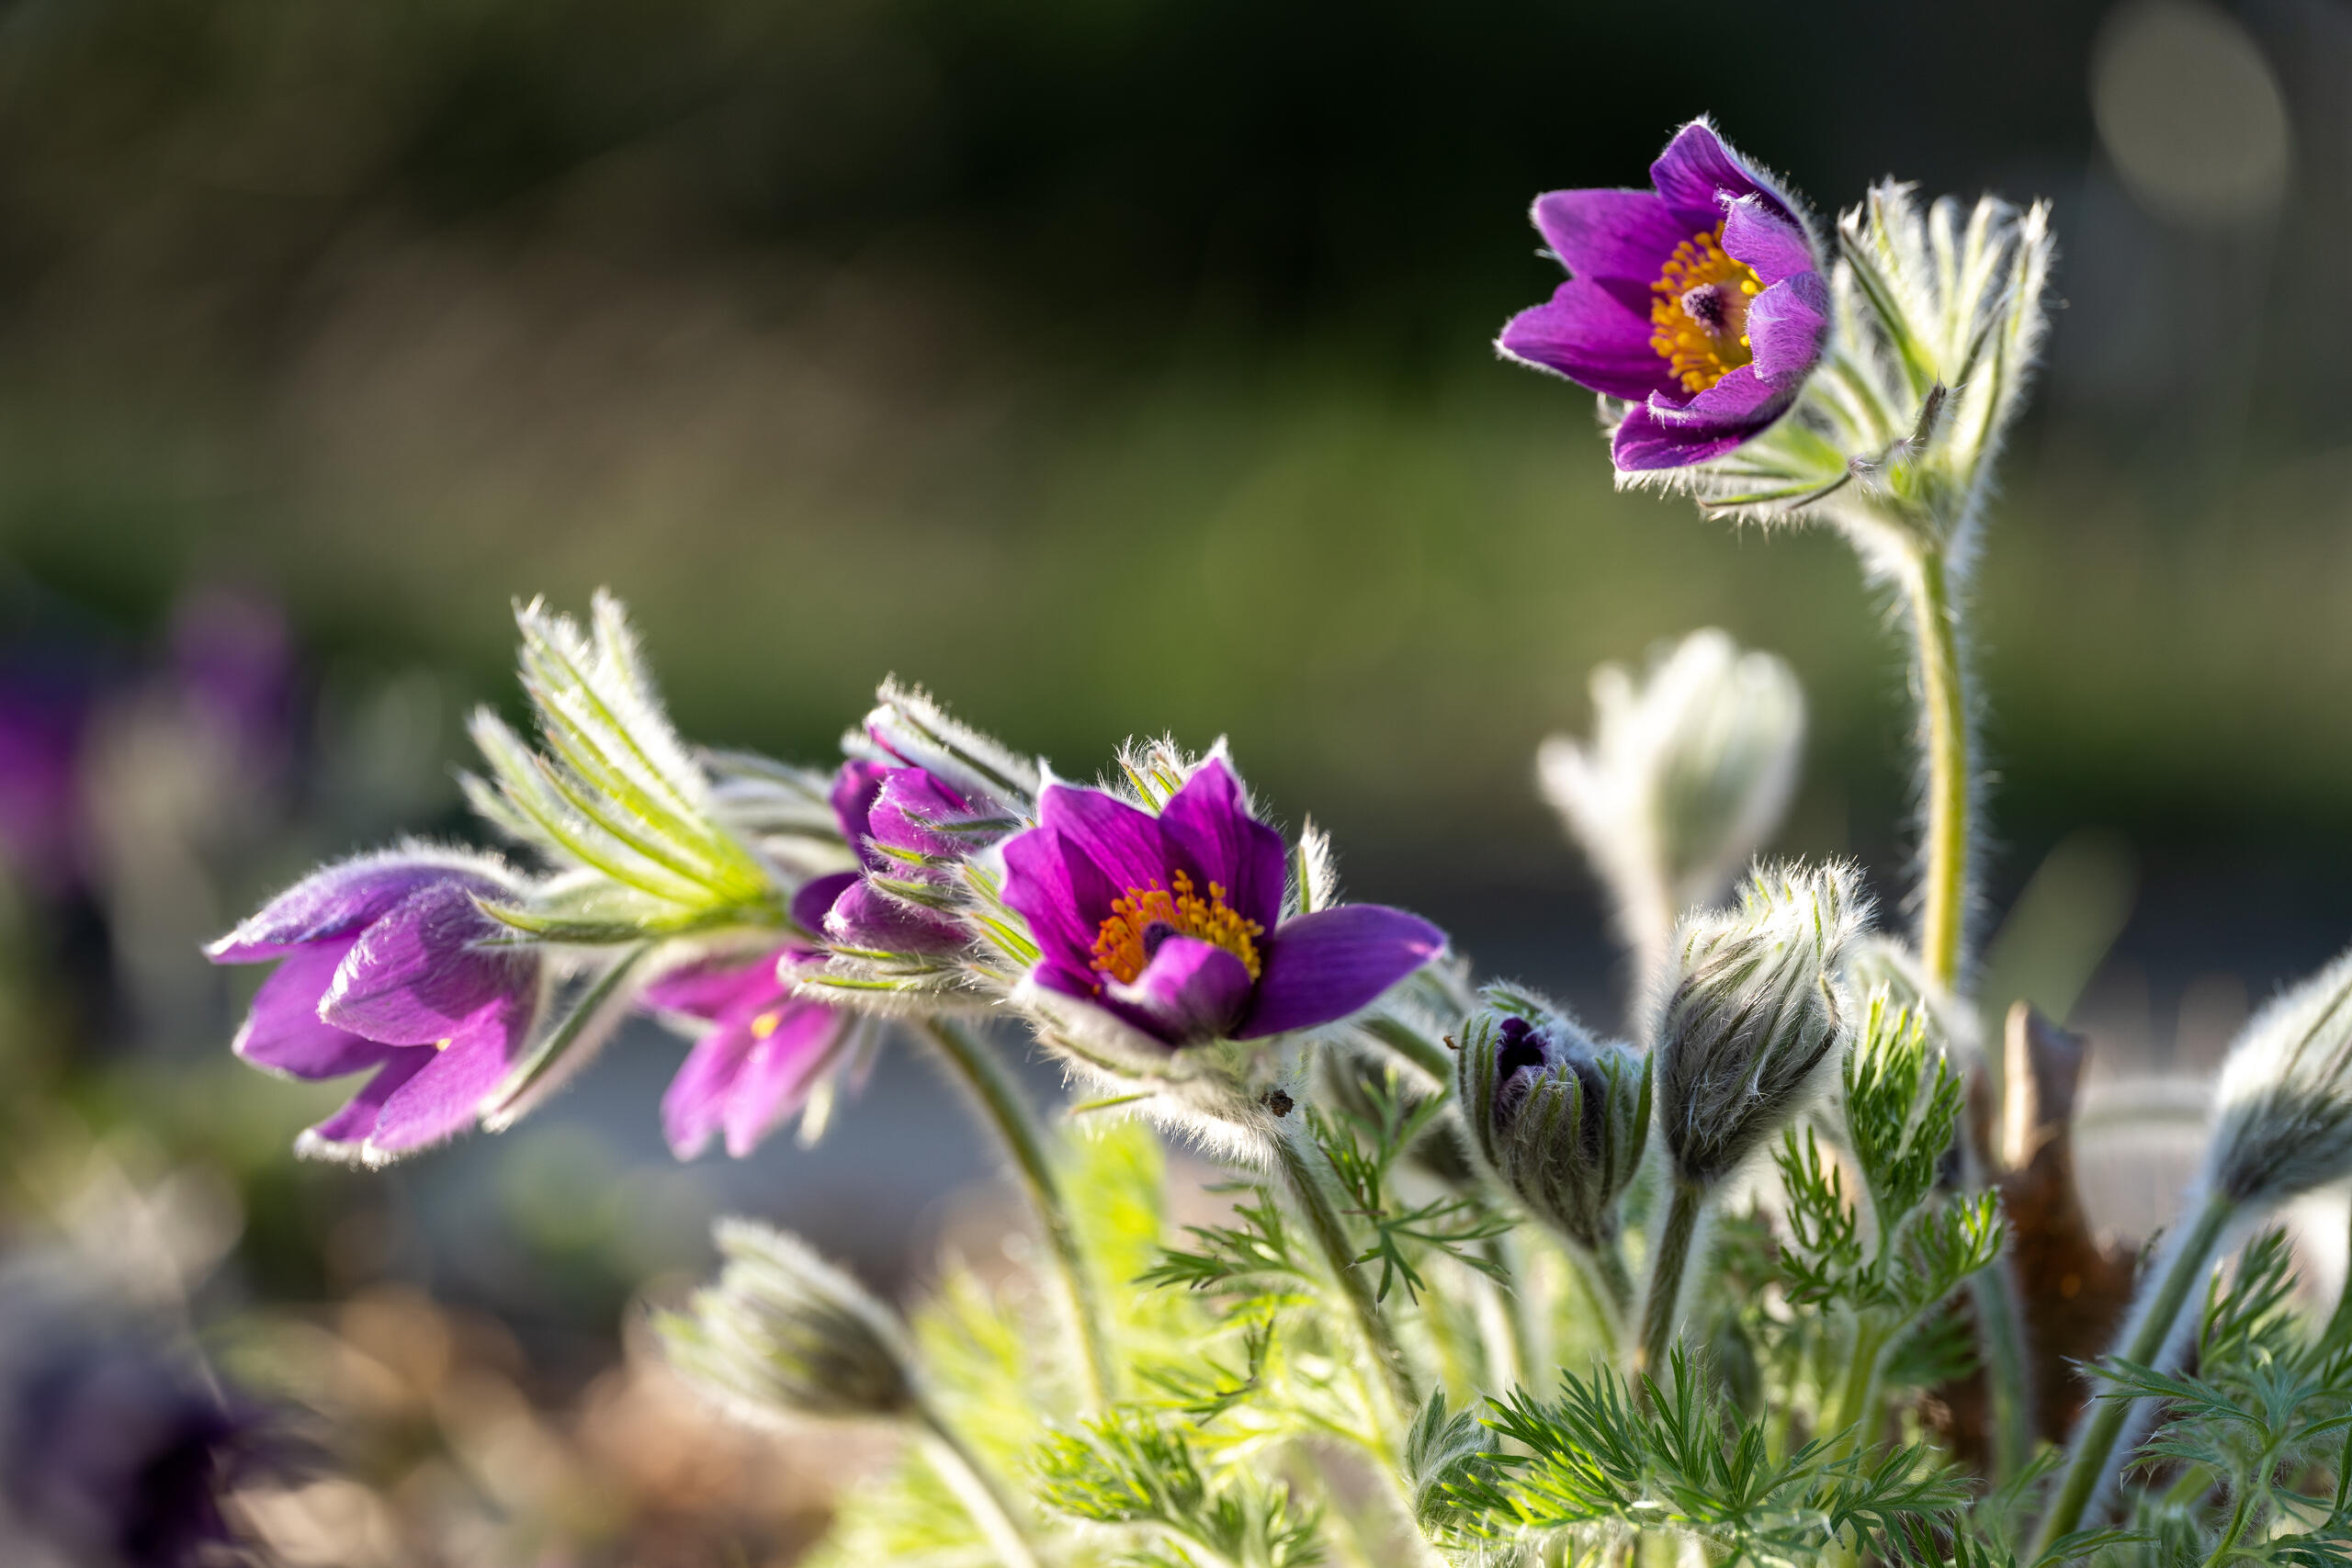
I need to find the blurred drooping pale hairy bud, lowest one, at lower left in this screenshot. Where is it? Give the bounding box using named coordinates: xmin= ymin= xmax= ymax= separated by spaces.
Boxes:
xmin=654 ymin=1220 xmax=915 ymax=1422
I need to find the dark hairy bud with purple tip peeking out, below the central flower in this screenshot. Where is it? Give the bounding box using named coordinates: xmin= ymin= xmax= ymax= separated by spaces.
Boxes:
xmin=1456 ymin=989 xmax=1649 ymax=1251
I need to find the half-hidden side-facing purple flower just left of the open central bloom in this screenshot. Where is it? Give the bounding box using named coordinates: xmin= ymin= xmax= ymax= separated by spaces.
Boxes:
xmin=793 ymin=757 xmax=1004 ymax=957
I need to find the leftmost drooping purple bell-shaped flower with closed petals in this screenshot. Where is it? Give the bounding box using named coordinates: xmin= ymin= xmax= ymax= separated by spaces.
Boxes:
xmin=205 ymin=846 xmax=538 ymax=1164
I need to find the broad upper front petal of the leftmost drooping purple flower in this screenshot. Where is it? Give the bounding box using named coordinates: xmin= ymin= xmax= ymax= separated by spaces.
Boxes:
xmin=318 ymin=882 xmax=537 ymax=1046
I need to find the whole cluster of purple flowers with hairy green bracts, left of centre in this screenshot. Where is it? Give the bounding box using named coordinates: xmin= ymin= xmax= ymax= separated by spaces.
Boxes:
xmin=209 ymin=597 xmax=1444 ymax=1164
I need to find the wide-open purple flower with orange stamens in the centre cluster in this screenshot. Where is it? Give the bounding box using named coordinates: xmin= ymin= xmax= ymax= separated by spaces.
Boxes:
xmin=1004 ymin=757 xmax=1446 ymax=1046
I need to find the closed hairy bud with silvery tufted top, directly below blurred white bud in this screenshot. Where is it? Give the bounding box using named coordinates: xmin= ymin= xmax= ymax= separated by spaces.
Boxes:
xmin=1658 ymin=865 xmax=1870 ymax=1185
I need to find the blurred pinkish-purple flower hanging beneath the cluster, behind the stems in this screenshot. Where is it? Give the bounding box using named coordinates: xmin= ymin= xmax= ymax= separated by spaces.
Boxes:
xmin=642 ymin=947 xmax=858 ymax=1159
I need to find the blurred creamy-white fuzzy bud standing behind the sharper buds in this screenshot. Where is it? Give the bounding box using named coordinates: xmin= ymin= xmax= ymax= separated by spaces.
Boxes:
xmin=1536 ymin=627 xmax=1804 ymax=968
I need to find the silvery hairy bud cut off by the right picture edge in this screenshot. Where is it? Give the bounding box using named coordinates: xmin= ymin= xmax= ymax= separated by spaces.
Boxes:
xmin=2206 ymin=952 xmax=2352 ymax=1208
